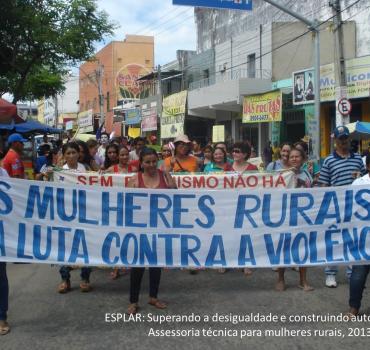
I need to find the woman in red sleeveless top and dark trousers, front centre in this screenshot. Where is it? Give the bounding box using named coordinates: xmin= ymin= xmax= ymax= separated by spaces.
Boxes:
xmin=127 ymin=148 xmax=176 ymax=315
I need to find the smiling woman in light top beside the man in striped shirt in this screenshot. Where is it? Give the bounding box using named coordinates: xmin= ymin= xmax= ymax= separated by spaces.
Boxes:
xmin=275 ymin=147 xmax=314 ymax=292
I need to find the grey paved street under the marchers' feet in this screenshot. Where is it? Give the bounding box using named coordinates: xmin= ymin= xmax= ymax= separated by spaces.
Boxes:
xmin=0 ymin=264 xmax=370 ymax=350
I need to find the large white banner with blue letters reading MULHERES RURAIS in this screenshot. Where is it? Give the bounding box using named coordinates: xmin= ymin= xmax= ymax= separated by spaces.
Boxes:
xmin=0 ymin=178 xmax=370 ymax=268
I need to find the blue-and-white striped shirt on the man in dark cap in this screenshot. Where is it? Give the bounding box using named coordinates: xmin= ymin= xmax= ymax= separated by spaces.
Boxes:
xmin=319 ymin=151 xmax=366 ymax=186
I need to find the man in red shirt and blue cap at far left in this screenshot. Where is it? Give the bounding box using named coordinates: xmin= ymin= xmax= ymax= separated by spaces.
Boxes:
xmin=3 ymin=134 xmax=27 ymax=179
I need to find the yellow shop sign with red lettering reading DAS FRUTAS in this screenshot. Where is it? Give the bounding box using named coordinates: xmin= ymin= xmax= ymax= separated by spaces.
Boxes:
xmin=243 ymin=90 xmax=283 ymax=123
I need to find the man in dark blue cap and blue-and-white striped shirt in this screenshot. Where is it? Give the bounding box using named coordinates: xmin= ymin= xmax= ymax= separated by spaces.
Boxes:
xmin=318 ymin=126 xmax=366 ymax=288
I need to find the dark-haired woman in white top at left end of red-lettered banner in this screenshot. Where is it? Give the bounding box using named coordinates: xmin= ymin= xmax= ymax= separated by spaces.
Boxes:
xmin=58 ymin=142 xmax=91 ymax=294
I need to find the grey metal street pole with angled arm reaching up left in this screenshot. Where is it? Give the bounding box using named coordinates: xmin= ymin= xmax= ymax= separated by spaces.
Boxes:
xmin=264 ymin=0 xmax=321 ymax=160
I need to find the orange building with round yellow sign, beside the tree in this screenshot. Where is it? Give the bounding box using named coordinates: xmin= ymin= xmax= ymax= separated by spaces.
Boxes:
xmin=79 ymin=35 xmax=154 ymax=135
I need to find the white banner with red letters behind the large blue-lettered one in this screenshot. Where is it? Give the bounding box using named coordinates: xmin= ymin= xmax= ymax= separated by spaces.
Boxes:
xmin=54 ymin=170 xmax=296 ymax=190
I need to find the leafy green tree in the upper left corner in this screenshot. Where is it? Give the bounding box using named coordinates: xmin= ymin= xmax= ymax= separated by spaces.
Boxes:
xmin=0 ymin=0 xmax=115 ymax=103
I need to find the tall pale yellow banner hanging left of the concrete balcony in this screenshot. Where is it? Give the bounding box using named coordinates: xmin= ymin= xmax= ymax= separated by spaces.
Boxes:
xmin=161 ymin=91 xmax=188 ymax=139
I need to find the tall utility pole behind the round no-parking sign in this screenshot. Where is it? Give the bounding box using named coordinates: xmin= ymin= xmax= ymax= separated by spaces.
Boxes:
xmin=329 ymin=0 xmax=349 ymax=126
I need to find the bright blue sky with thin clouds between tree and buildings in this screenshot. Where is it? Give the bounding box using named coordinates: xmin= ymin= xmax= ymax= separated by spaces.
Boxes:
xmin=97 ymin=0 xmax=196 ymax=65
